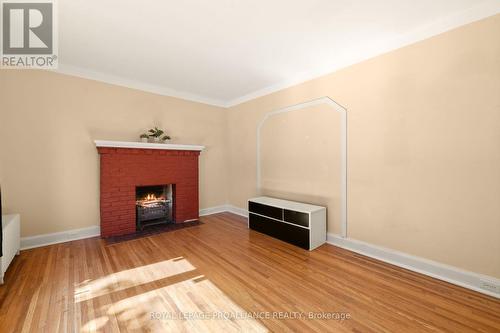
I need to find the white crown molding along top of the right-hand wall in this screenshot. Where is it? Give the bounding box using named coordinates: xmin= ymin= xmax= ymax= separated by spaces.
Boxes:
xmin=225 ymin=0 xmax=500 ymax=108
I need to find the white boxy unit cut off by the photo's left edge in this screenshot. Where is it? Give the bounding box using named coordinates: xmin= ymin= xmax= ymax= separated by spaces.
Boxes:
xmin=0 ymin=214 xmax=21 ymax=284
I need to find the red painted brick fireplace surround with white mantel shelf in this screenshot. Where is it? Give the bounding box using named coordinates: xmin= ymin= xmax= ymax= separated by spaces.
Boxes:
xmin=95 ymin=141 xmax=204 ymax=237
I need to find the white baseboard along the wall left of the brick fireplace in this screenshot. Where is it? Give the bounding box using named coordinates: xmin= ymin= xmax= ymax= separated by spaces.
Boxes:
xmin=21 ymin=226 xmax=101 ymax=250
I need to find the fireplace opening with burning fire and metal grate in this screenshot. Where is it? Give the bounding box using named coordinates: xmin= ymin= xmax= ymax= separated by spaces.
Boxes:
xmin=135 ymin=184 xmax=175 ymax=231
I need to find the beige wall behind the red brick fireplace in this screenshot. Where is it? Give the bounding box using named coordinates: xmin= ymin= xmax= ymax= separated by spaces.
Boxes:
xmin=0 ymin=70 xmax=227 ymax=236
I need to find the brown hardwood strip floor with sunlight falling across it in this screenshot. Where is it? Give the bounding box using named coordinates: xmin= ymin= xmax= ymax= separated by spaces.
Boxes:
xmin=0 ymin=213 xmax=500 ymax=332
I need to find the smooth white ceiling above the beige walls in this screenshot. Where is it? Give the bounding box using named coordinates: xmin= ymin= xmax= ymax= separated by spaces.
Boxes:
xmin=58 ymin=0 xmax=500 ymax=106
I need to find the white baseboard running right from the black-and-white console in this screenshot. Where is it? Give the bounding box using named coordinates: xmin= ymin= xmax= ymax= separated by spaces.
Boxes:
xmin=327 ymin=233 xmax=500 ymax=298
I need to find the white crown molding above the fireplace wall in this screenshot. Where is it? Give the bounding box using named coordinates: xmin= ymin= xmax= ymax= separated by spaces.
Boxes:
xmin=51 ymin=63 xmax=227 ymax=108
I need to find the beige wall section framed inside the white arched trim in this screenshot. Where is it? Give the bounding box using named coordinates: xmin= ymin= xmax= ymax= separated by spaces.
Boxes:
xmin=259 ymin=104 xmax=342 ymax=233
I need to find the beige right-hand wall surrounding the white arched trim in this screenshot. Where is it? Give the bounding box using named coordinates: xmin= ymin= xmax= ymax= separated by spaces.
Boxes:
xmin=228 ymin=15 xmax=500 ymax=277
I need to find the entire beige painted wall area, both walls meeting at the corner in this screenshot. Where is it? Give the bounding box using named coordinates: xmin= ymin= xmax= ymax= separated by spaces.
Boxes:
xmin=0 ymin=15 xmax=500 ymax=277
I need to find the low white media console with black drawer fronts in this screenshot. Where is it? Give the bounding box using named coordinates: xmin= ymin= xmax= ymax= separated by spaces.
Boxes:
xmin=248 ymin=197 xmax=326 ymax=250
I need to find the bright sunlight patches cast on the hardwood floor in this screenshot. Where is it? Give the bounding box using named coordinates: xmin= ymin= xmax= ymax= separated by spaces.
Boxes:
xmin=75 ymin=259 xmax=267 ymax=332
